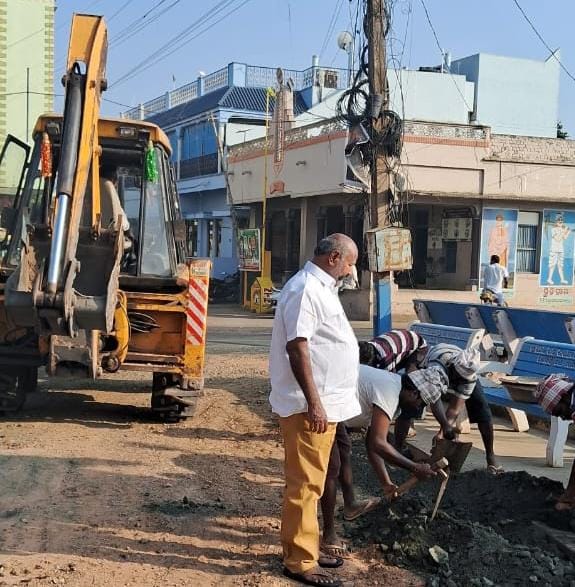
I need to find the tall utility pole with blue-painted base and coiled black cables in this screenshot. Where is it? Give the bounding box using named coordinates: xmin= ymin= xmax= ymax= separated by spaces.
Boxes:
xmin=367 ymin=0 xmax=391 ymax=336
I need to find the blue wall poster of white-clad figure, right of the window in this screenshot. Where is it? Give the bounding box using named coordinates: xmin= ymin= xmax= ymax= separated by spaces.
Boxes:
xmin=539 ymin=209 xmax=575 ymax=305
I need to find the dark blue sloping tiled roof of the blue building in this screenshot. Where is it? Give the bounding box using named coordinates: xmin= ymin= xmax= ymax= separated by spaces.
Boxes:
xmin=146 ymin=86 xmax=308 ymax=127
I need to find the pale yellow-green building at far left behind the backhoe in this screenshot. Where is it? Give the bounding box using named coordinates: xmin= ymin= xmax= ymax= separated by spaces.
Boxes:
xmin=0 ymin=0 xmax=55 ymax=198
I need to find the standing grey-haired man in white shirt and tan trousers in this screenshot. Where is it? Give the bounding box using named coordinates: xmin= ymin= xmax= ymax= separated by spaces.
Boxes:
xmin=269 ymin=234 xmax=361 ymax=586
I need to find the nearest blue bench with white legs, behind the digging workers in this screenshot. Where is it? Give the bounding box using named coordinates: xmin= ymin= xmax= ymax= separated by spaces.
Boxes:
xmin=479 ymin=337 xmax=575 ymax=467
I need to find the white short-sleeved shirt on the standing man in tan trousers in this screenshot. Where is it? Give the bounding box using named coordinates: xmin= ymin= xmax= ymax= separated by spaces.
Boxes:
xmin=269 ymin=261 xmax=360 ymax=422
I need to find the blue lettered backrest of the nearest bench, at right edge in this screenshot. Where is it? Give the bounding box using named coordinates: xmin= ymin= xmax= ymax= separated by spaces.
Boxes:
xmin=511 ymin=338 xmax=575 ymax=379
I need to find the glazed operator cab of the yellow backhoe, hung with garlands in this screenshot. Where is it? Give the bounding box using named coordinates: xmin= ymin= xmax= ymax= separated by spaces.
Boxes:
xmin=0 ymin=117 xmax=186 ymax=289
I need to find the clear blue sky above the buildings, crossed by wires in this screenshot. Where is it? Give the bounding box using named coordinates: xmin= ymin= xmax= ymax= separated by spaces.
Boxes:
xmin=56 ymin=0 xmax=575 ymax=138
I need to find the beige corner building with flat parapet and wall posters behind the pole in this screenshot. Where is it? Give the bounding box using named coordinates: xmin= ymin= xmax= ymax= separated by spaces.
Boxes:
xmin=229 ymin=115 xmax=575 ymax=319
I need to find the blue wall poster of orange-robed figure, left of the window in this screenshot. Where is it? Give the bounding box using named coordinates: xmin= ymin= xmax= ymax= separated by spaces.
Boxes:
xmin=479 ymin=208 xmax=519 ymax=291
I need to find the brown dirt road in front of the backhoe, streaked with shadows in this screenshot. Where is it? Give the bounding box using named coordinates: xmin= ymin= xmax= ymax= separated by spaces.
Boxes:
xmin=0 ymin=345 xmax=422 ymax=587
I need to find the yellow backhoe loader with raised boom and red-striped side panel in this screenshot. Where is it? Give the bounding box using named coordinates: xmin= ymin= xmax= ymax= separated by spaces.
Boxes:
xmin=0 ymin=15 xmax=209 ymax=419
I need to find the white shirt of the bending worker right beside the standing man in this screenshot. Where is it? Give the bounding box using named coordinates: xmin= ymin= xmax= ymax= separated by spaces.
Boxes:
xmin=346 ymin=365 xmax=401 ymax=428
